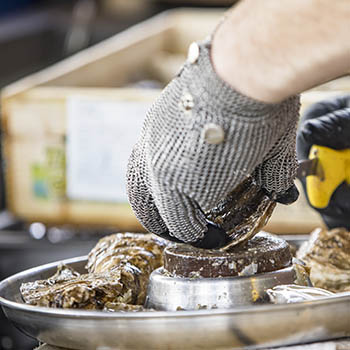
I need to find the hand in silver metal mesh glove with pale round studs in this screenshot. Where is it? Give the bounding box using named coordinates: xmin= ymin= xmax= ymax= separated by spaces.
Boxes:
xmin=127 ymin=42 xmax=299 ymax=248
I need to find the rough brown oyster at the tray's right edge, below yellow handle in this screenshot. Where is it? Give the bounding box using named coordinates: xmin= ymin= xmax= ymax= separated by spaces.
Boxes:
xmin=297 ymin=228 xmax=350 ymax=292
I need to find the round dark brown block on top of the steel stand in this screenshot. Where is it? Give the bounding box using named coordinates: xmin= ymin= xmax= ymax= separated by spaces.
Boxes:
xmin=164 ymin=232 xmax=292 ymax=277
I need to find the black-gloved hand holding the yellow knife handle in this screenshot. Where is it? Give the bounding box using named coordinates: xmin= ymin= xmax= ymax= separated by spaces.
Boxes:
xmin=297 ymin=95 xmax=350 ymax=230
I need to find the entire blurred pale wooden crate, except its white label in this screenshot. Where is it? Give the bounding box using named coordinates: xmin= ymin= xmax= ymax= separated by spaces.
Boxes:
xmin=1 ymin=9 xmax=348 ymax=233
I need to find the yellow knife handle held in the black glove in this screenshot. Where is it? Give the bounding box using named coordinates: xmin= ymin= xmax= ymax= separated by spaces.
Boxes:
xmin=306 ymin=145 xmax=350 ymax=209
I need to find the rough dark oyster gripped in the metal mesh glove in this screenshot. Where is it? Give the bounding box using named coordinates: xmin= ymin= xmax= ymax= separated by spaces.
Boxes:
xmin=206 ymin=177 xmax=276 ymax=250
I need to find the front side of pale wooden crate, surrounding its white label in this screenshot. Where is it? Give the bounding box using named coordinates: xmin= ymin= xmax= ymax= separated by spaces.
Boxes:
xmin=4 ymin=87 xmax=159 ymax=230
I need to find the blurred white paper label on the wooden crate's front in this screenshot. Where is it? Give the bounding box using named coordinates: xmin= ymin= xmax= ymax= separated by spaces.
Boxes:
xmin=66 ymin=96 xmax=151 ymax=202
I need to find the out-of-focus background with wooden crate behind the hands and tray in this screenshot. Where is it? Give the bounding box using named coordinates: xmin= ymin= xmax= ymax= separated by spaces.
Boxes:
xmin=0 ymin=0 xmax=344 ymax=350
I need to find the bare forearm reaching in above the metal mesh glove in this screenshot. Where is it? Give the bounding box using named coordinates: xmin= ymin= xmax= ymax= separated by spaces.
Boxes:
xmin=211 ymin=0 xmax=350 ymax=102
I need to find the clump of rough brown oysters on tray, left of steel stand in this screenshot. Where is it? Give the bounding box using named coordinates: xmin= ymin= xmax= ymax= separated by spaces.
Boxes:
xmin=21 ymin=233 xmax=165 ymax=311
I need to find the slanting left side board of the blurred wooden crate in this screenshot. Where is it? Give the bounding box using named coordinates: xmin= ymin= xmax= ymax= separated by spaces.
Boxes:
xmin=1 ymin=14 xmax=171 ymax=98
